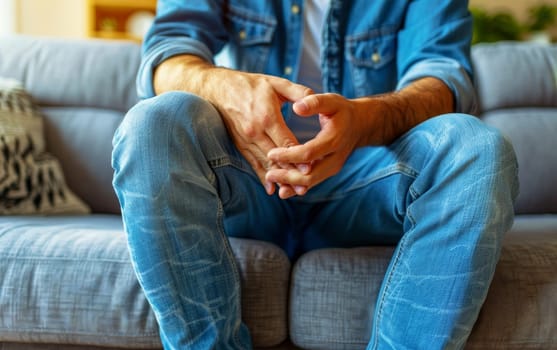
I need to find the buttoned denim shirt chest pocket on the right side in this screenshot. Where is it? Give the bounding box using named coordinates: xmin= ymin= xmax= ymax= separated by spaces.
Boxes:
xmin=345 ymin=27 xmax=397 ymax=96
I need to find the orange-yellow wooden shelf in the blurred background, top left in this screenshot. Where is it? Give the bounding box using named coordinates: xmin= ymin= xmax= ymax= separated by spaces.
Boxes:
xmin=87 ymin=0 xmax=157 ymax=41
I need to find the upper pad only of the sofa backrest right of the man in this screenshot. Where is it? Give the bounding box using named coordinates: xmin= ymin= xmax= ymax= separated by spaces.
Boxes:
xmin=472 ymin=42 xmax=557 ymax=112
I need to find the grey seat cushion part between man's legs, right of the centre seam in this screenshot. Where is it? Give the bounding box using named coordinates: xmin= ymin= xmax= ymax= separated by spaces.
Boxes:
xmin=290 ymin=247 xmax=394 ymax=349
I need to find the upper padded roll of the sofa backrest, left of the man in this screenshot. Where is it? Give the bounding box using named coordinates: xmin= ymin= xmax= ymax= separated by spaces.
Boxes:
xmin=0 ymin=35 xmax=140 ymax=112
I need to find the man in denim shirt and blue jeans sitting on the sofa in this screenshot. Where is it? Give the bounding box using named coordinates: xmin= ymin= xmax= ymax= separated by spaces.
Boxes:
xmin=113 ymin=0 xmax=517 ymax=350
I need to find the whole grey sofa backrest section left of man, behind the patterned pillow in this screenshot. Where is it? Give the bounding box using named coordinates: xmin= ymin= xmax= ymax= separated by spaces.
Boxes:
xmin=0 ymin=35 xmax=140 ymax=213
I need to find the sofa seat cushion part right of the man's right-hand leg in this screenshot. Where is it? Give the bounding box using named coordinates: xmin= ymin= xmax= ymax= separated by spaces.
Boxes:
xmin=467 ymin=215 xmax=557 ymax=350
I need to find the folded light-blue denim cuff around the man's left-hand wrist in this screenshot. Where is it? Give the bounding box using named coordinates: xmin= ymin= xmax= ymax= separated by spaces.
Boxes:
xmin=136 ymin=37 xmax=213 ymax=99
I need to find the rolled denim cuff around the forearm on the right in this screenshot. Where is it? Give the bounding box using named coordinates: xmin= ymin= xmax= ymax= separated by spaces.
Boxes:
xmin=397 ymin=58 xmax=477 ymax=114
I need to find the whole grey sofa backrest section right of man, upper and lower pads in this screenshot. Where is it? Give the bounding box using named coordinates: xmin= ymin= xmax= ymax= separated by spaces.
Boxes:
xmin=472 ymin=42 xmax=557 ymax=214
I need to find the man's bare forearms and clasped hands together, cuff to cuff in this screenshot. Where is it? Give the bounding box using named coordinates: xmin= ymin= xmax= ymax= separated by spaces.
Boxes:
xmin=154 ymin=55 xmax=448 ymax=199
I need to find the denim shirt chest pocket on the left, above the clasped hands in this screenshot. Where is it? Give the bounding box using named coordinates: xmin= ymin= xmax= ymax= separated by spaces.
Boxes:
xmin=226 ymin=6 xmax=277 ymax=72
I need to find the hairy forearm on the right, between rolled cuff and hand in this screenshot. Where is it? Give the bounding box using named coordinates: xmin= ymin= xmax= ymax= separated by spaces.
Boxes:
xmin=356 ymin=77 xmax=454 ymax=145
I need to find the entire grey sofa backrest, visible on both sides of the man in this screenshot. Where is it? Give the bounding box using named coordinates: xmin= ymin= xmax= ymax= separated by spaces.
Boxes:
xmin=0 ymin=36 xmax=557 ymax=213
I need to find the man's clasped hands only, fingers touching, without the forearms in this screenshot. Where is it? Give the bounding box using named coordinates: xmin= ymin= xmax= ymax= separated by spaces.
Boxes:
xmin=219 ymin=73 xmax=365 ymax=199
